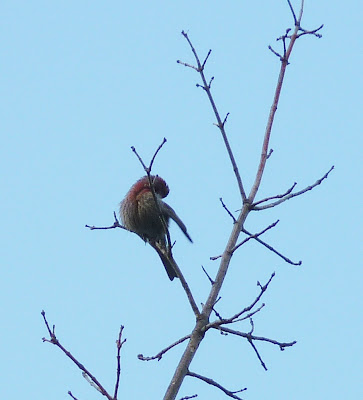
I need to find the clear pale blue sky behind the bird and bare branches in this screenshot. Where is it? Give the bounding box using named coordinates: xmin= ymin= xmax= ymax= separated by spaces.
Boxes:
xmin=0 ymin=0 xmax=363 ymax=400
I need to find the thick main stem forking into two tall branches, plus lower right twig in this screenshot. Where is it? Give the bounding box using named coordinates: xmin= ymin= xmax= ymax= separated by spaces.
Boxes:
xmin=164 ymin=0 xmax=324 ymax=400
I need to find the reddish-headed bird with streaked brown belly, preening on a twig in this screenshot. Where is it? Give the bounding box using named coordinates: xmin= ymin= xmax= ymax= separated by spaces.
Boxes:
xmin=120 ymin=175 xmax=192 ymax=280
